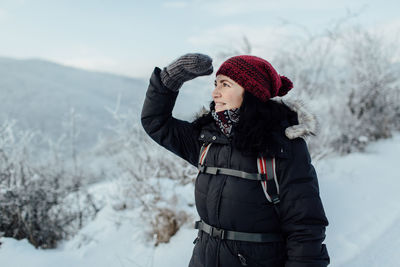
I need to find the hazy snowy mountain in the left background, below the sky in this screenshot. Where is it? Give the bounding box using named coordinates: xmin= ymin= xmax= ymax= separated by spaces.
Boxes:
xmin=0 ymin=57 xmax=212 ymax=148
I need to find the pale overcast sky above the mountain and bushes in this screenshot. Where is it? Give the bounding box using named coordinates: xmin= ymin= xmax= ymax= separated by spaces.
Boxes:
xmin=0 ymin=0 xmax=400 ymax=78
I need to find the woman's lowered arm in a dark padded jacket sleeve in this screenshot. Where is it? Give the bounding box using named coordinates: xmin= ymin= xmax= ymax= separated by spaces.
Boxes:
xmin=280 ymin=138 xmax=330 ymax=267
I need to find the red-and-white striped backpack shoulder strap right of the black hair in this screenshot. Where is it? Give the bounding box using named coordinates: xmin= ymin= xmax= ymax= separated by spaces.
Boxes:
xmin=257 ymin=157 xmax=279 ymax=204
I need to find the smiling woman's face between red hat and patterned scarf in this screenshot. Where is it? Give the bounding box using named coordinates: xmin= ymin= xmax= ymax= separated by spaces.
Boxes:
xmin=212 ymin=74 xmax=244 ymax=112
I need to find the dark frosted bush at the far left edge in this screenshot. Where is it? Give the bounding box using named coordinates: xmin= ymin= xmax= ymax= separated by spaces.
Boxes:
xmin=0 ymin=122 xmax=98 ymax=248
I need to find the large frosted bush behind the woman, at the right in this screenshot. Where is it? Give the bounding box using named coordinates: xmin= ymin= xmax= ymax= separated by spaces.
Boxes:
xmin=272 ymin=21 xmax=400 ymax=158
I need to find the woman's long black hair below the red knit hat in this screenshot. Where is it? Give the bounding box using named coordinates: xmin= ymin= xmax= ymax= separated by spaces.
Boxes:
xmin=193 ymin=91 xmax=298 ymax=156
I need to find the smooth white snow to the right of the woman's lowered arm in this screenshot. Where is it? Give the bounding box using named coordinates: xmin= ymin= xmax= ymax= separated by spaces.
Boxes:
xmin=316 ymin=134 xmax=400 ymax=266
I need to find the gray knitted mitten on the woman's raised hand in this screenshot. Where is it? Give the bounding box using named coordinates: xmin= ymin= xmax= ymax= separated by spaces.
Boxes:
xmin=160 ymin=53 xmax=213 ymax=91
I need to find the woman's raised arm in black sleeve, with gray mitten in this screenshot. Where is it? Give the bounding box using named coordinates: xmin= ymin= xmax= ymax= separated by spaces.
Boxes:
xmin=141 ymin=54 xmax=212 ymax=167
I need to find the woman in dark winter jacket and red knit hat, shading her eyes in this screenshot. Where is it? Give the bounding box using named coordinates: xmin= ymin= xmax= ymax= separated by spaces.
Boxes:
xmin=141 ymin=54 xmax=329 ymax=267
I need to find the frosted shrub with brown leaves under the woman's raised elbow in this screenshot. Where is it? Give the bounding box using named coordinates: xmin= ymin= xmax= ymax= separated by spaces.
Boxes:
xmin=96 ymin=109 xmax=197 ymax=245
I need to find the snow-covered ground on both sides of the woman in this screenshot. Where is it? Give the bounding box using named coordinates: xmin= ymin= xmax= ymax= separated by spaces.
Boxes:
xmin=0 ymin=134 xmax=400 ymax=267
